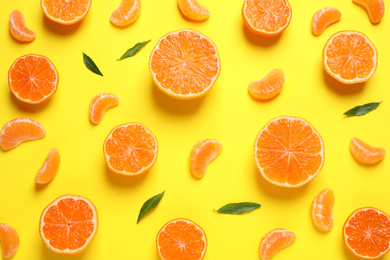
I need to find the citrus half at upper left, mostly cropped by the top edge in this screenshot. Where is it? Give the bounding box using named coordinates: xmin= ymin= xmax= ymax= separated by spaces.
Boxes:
xmin=41 ymin=0 xmax=92 ymax=25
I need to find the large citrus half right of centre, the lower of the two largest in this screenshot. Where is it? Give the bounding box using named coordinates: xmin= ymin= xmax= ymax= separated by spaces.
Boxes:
xmin=254 ymin=116 xmax=324 ymax=188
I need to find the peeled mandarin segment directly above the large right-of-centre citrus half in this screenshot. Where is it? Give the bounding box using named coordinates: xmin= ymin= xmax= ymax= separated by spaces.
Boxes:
xmin=248 ymin=69 xmax=285 ymax=100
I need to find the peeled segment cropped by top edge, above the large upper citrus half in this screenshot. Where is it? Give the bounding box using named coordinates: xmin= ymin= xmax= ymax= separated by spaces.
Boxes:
xmin=177 ymin=0 xmax=210 ymax=22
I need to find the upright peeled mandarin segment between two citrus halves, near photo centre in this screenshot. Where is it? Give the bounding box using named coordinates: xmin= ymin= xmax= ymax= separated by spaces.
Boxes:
xmin=190 ymin=139 xmax=222 ymax=178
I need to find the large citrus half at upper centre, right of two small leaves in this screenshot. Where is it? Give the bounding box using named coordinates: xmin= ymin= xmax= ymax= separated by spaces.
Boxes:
xmin=149 ymin=29 xmax=221 ymax=99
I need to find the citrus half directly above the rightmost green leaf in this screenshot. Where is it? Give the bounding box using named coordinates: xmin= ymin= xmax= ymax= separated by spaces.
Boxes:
xmin=322 ymin=31 xmax=378 ymax=84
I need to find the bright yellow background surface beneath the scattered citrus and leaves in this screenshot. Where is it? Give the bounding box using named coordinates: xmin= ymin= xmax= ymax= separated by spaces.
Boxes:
xmin=0 ymin=0 xmax=390 ymax=260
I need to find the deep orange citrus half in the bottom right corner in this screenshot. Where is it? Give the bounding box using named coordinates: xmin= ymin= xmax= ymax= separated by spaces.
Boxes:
xmin=343 ymin=207 xmax=390 ymax=259
